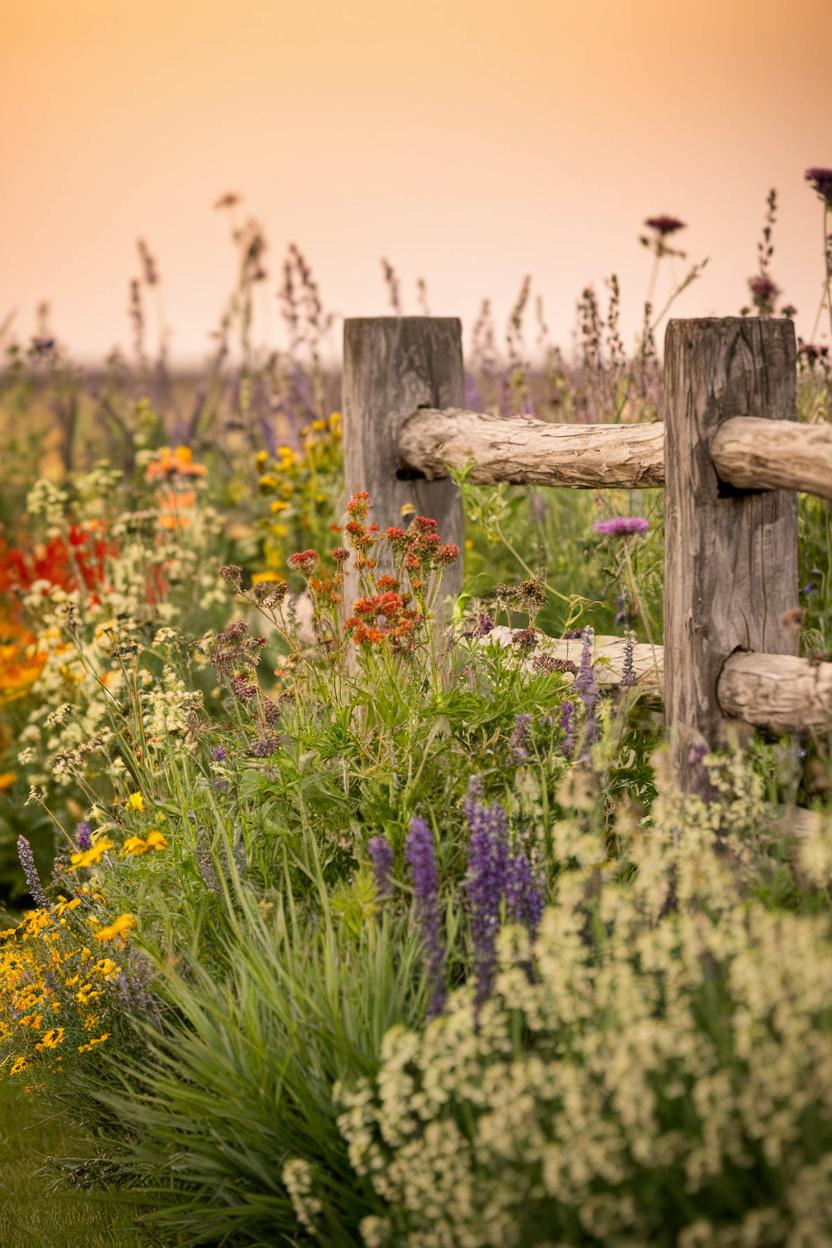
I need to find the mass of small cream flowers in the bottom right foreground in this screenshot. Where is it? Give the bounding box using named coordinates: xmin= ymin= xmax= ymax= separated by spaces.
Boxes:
xmin=338 ymin=788 xmax=832 ymax=1248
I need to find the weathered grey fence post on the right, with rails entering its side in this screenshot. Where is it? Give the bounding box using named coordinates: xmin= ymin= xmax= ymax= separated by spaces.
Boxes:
xmin=664 ymin=317 xmax=797 ymax=796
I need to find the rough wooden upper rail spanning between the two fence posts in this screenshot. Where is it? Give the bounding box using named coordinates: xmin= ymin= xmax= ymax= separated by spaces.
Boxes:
xmin=399 ymin=411 xmax=665 ymax=489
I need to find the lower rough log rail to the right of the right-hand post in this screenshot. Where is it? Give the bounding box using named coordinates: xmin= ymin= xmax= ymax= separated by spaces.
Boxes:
xmin=717 ymin=654 xmax=832 ymax=733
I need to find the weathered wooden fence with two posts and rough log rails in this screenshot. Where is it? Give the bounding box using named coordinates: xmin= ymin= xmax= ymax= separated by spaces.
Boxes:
xmin=343 ymin=317 xmax=832 ymax=795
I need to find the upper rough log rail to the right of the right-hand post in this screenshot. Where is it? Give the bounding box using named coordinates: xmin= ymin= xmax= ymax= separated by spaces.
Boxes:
xmin=711 ymin=416 xmax=832 ymax=498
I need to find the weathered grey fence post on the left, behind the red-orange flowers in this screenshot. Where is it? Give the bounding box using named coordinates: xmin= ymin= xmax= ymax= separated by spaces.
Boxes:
xmin=343 ymin=317 xmax=465 ymax=603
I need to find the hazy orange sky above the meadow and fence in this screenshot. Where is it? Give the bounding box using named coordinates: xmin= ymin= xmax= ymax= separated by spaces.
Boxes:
xmin=0 ymin=0 xmax=832 ymax=358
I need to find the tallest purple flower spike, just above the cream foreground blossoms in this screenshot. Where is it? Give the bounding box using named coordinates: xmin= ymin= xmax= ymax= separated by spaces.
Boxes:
xmin=464 ymin=779 xmax=509 ymax=1011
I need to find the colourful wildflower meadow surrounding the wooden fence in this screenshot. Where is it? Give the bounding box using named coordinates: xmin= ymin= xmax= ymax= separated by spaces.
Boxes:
xmin=0 ymin=167 xmax=832 ymax=1248
